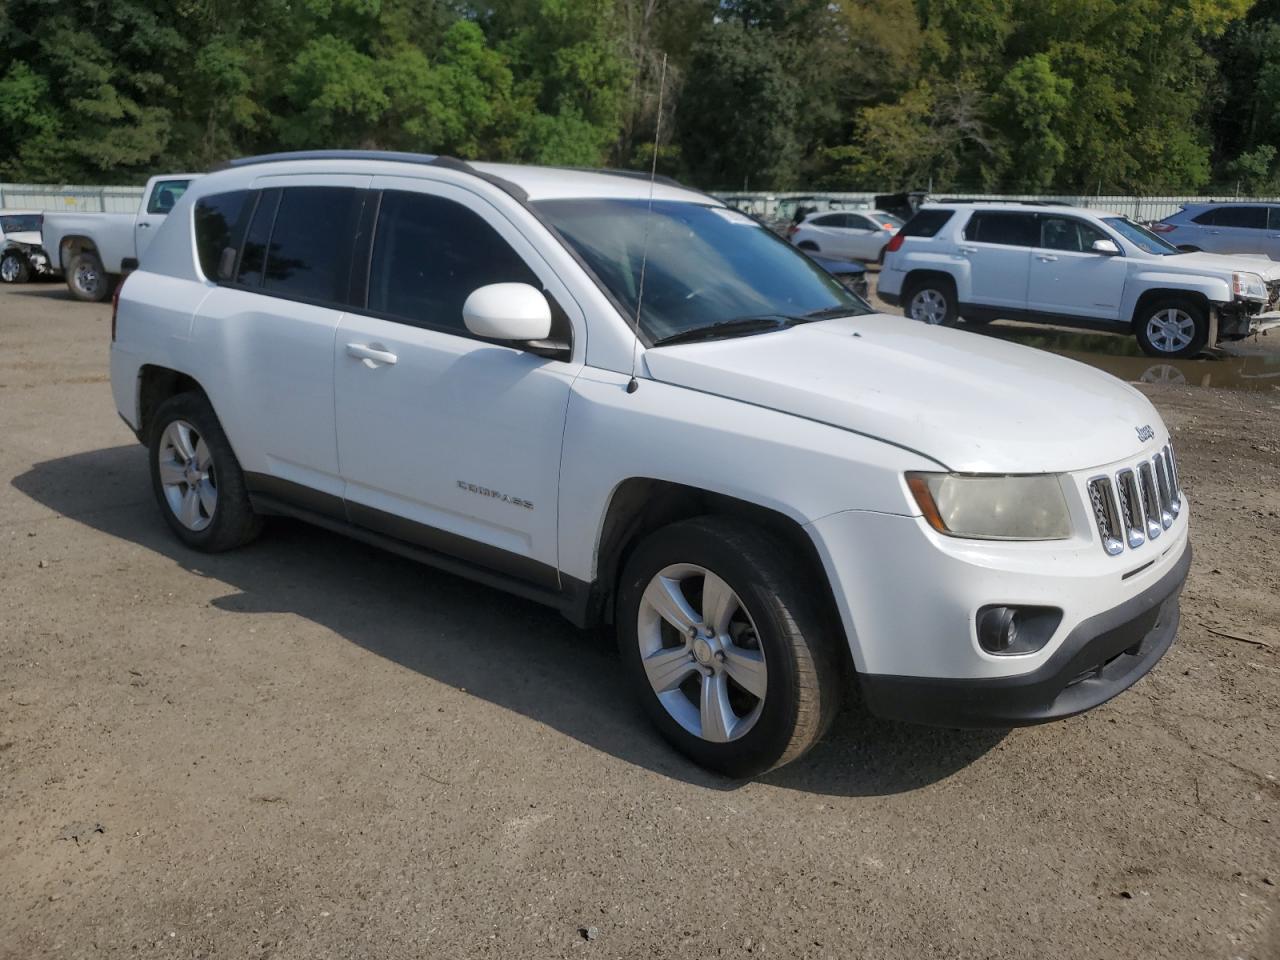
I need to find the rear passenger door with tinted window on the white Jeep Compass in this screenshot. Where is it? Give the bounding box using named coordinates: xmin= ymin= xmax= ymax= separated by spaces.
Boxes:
xmin=193 ymin=175 xmax=370 ymax=504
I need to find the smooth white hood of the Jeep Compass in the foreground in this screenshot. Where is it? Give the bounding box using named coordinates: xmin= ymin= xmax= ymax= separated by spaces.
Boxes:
xmin=645 ymin=314 xmax=1164 ymax=474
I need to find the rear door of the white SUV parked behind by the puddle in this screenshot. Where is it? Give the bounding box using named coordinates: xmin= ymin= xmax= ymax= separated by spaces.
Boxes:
xmin=956 ymin=210 xmax=1039 ymax=310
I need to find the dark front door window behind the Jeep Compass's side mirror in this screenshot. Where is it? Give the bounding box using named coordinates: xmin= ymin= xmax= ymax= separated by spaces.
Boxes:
xmin=369 ymin=191 xmax=541 ymax=335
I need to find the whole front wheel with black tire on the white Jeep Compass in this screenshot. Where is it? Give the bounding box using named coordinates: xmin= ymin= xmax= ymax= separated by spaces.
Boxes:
xmin=617 ymin=517 xmax=840 ymax=778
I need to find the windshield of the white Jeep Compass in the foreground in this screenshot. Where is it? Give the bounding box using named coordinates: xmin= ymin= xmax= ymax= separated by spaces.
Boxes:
xmin=534 ymin=198 xmax=870 ymax=343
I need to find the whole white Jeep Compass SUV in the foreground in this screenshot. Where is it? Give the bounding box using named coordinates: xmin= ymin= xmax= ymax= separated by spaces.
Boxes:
xmin=111 ymin=151 xmax=1190 ymax=776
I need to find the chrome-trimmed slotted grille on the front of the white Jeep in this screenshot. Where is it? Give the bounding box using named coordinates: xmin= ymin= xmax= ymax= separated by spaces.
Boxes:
xmin=1087 ymin=444 xmax=1183 ymax=557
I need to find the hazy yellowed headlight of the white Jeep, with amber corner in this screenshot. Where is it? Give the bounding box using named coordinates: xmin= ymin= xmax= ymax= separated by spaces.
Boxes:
xmin=906 ymin=474 xmax=1071 ymax=540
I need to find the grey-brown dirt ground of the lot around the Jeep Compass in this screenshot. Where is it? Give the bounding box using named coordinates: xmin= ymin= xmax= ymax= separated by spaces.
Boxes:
xmin=0 ymin=284 xmax=1280 ymax=960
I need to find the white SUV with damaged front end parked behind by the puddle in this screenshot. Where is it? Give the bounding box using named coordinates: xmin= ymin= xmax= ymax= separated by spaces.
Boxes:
xmin=877 ymin=202 xmax=1280 ymax=357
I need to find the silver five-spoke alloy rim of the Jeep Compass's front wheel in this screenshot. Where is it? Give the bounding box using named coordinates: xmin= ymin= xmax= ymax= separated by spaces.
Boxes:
xmin=636 ymin=563 xmax=768 ymax=744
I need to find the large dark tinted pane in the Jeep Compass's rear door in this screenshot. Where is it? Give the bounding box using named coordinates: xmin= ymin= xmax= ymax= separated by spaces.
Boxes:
xmin=257 ymin=187 xmax=364 ymax=303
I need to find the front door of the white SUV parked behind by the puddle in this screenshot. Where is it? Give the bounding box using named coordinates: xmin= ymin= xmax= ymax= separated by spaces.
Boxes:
xmin=1027 ymin=214 xmax=1129 ymax=320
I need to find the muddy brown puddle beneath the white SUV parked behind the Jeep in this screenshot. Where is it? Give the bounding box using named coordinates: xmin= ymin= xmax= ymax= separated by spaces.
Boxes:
xmin=970 ymin=323 xmax=1280 ymax=392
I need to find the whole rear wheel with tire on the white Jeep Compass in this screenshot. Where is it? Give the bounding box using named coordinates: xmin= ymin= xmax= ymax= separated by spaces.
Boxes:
xmin=147 ymin=393 xmax=262 ymax=553
